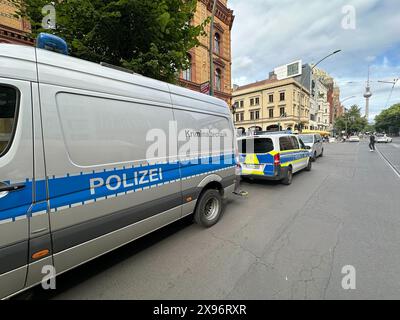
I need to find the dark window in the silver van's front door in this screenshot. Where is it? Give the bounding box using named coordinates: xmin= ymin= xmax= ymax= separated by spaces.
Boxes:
xmin=0 ymin=84 xmax=18 ymax=157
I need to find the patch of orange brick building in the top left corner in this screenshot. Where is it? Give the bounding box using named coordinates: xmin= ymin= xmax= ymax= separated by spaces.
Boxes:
xmin=0 ymin=0 xmax=34 ymax=45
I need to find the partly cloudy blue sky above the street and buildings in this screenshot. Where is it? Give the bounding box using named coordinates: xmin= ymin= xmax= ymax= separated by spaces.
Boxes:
xmin=228 ymin=0 xmax=400 ymax=121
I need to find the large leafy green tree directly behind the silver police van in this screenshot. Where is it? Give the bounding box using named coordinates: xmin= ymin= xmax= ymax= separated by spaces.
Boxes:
xmin=12 ymin=0 xmax=208 ymax=83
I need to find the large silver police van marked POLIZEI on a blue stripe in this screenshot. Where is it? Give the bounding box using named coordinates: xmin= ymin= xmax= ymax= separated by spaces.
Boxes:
xmin=0 ymin=44 xmax=236 ymax=298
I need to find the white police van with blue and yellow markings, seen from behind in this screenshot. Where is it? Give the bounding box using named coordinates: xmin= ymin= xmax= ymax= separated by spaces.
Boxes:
xmin=238 ymin=132 xmax=312 ymax=185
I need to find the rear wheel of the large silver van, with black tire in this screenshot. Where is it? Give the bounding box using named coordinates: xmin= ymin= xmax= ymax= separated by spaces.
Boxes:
xmin=194 ymin=189 xmax=222 ymax=228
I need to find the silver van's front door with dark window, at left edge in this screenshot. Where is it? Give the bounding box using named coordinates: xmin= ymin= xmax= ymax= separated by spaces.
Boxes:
xmin=0 ymin=77 xmax=33 ymax=298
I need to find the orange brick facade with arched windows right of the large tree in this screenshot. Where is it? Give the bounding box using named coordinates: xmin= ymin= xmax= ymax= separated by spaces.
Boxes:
xmin=180 ymin=0 xmax=235 ymax=105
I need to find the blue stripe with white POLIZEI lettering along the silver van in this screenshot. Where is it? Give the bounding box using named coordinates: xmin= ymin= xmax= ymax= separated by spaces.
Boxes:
xmin=0 ymin=154 xmax=235 ymax=221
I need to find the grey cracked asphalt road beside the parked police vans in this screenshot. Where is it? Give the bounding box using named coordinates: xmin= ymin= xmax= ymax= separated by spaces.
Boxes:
xmin=28 ymin=140 xmax=400 ymax=300
